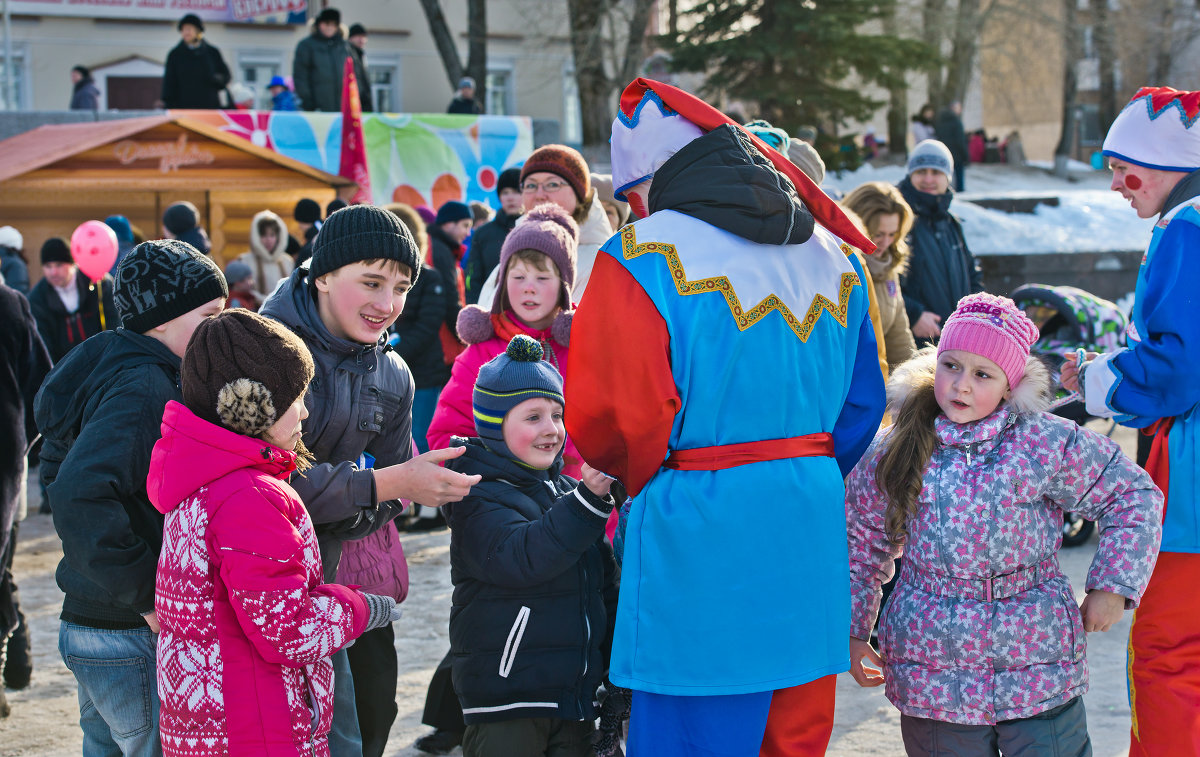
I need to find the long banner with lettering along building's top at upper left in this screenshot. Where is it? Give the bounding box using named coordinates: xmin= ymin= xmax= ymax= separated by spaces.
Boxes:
xmin=8 ymin=0 xmax=308 ymax=24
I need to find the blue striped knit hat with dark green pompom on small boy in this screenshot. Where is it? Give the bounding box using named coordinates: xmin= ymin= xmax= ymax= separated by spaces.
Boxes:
xmin=472 ymin=334 xmax=566 ymax=459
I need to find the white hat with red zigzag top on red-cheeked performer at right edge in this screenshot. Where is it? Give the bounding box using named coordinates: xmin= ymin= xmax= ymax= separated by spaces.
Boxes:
xmin=1102 ymin=86 xmax=1200 ymax=173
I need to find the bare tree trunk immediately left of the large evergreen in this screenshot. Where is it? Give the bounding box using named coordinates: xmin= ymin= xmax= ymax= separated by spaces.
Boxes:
xmin=564 ymin=0 xmax=654 ymax=148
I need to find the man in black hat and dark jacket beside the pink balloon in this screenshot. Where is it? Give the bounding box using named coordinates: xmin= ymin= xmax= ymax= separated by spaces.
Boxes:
xmin=29 ymin=236 xmax=118 ymax=362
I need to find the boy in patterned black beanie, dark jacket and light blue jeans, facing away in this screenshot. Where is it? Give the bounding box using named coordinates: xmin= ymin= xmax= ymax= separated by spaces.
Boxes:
xmin=34 ymin=240 xmax=228 ymax=755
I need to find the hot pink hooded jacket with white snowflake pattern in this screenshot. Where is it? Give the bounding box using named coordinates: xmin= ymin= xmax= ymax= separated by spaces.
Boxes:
xmin=146 ymin=401 xmax=370 ymax=757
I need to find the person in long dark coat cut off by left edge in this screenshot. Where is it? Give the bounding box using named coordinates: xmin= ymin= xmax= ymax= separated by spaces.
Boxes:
xmin=0 ymin=284 xmax=50 ymax=717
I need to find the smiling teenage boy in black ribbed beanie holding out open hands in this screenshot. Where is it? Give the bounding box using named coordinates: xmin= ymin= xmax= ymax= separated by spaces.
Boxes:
xmin=260 ymin=205 xmax=479 ymax=757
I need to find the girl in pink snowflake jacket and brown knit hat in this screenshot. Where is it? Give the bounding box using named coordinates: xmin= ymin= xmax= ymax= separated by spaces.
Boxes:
xmin=146 ymin=308 xmax=398 ymax=757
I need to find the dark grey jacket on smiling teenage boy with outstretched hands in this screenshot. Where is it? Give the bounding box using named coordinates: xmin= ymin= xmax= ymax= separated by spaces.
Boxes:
xmin=259 ymin=265 xmax=413 ymax=582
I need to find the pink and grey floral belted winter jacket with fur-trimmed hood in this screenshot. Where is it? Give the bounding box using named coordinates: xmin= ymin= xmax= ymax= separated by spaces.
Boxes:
xmin=846 ymin=353 xmax=1163 ymax=725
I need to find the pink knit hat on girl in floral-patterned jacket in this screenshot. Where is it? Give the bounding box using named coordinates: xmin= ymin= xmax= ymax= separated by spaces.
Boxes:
xmin=937 ymin=292 xmax=1039 ymax=389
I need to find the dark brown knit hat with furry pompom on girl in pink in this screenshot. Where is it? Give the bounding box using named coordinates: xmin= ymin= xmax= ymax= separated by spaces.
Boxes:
xmin=180 ymin=307 xmax=313 ymax=437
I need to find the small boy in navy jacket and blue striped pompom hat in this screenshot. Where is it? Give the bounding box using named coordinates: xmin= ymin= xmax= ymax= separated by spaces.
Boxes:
xmin=444 ymin=335 xmax=617 ymax=757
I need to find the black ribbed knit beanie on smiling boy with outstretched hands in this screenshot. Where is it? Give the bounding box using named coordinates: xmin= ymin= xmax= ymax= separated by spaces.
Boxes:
xmin=308 ymin=205 xmax=421 ymax=283
